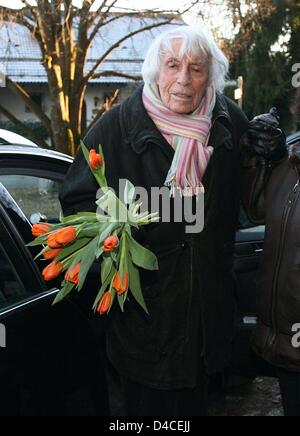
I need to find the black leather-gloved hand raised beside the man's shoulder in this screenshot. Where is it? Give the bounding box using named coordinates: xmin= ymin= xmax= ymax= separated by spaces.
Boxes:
xmin=241 ymin=108 xmax=288 ymax=164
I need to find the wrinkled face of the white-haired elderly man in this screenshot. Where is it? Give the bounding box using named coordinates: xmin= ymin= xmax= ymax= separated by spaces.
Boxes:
xmin=157 ymin=39 xmax=209 ymax=114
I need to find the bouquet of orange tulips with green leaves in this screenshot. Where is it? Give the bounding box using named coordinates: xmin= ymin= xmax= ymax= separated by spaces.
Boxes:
xmin=29 ymin=143 xmax=159 ymax=315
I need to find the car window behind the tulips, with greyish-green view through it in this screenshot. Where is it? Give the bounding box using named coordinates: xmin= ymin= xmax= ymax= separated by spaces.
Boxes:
xmin=0 ymin=174 xmax=61 ymax=221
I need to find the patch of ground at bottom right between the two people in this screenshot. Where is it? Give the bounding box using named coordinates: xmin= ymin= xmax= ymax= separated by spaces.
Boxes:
xmin=209 ymin=378 xmax=283 ymax=416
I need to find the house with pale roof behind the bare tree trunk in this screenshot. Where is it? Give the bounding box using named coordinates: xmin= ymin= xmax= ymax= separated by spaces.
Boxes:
xmin=0 ymin=16 xmax=184 ymax=135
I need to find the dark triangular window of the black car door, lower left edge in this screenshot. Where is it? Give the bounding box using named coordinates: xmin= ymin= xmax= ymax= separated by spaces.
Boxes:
xmin=0 ymin=244 xmax=29 ymax=310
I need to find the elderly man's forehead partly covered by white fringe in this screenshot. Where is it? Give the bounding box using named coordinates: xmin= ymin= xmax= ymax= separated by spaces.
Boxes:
xmin=160 ymin=37 xmax=210 ymax=65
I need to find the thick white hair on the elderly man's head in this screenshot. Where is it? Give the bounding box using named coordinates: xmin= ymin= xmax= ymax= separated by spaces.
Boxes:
xmin=142 ymin=26 xmax=229 ymax=92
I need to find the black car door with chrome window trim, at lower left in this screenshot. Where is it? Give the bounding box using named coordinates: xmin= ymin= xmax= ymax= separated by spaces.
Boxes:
xmin=0 ymin=184 xmax=108 ymax=416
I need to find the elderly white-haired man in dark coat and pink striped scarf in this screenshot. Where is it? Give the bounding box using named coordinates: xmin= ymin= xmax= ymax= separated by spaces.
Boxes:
xmin=61 ymin=26 xmax=281 ymax=416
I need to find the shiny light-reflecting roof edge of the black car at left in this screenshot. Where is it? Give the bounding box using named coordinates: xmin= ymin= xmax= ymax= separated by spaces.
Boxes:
xmin=0 ymin=144 xmax=73 ymax=164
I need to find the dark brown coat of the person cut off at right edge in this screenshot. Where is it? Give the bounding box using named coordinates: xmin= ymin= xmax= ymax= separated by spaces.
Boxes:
xmin=243 ymin=158 xmax=300 ymax=372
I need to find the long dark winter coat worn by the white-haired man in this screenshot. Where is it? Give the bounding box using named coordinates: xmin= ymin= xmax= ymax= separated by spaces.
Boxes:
xmin=61 ymin=88 xmax=248 ymax=389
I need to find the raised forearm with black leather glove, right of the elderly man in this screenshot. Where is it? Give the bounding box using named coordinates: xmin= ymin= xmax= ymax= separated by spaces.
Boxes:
xmin=240 ymin=109 xmax=288 ymax=224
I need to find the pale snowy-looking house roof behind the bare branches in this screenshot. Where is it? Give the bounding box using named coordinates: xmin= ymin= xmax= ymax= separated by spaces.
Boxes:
xmin=0 ymin=16 xmax=183 ymax=84
